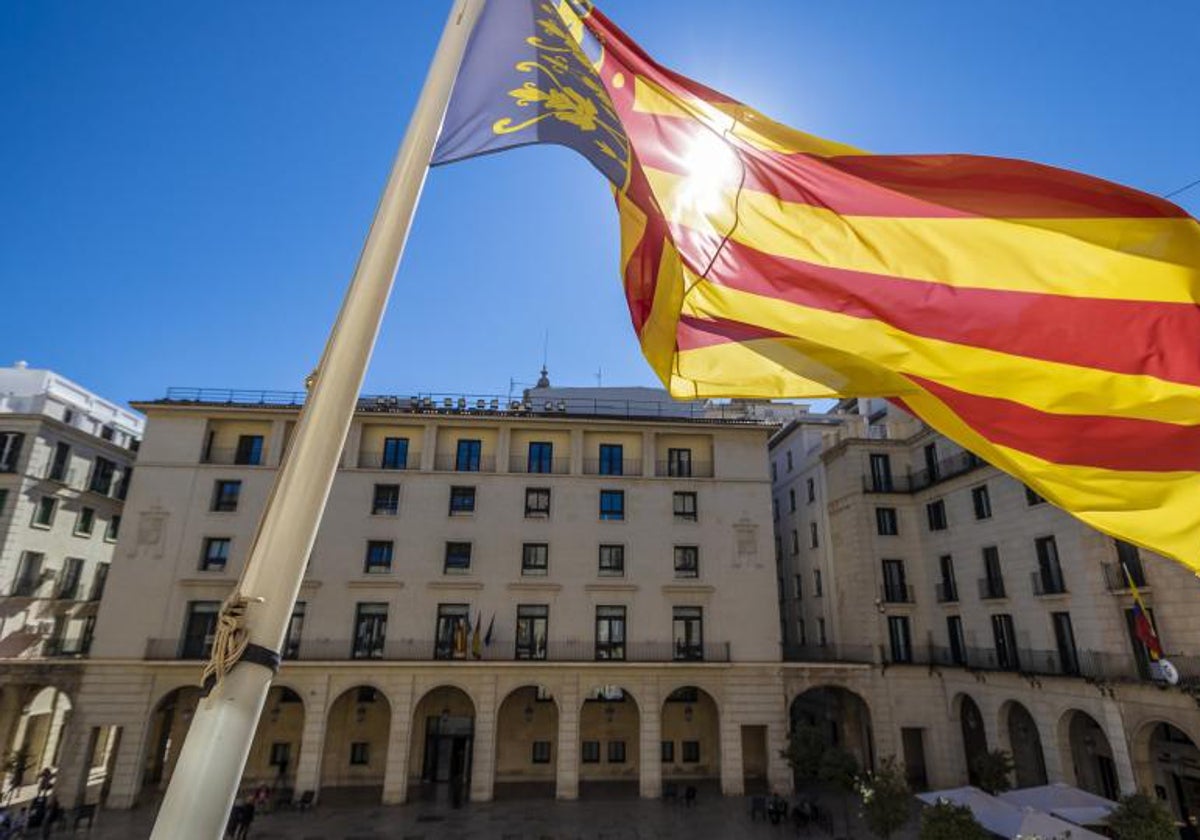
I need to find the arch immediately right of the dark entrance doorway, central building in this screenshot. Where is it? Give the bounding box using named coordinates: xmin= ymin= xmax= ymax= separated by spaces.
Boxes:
xmin=494 ymin=684 xmax=558 ymax=799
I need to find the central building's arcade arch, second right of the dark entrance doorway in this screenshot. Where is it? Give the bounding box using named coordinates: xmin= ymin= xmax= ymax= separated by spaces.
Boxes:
xmin=580 ymin=685 xmax=642 ymax=797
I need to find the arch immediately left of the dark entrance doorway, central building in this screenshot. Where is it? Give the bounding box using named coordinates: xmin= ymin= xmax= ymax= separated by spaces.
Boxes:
xmin=320 ymin=683 xmax=391 ymax=804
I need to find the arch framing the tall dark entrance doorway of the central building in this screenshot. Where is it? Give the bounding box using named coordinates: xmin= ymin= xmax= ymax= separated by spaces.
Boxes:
xmin=408 ymin=683 xmax=476 ymax=804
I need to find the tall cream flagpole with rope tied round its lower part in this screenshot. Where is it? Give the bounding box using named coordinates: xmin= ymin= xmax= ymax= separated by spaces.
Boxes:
xmin=151 ymin=0 xmax=485 ymax=840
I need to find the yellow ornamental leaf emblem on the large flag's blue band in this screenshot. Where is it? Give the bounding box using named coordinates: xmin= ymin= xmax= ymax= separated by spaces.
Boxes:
xmin=492 ymin=2 xmax=630 ymax=182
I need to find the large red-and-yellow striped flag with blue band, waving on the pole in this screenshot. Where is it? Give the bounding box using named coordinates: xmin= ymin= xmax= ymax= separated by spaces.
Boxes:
xmin=434 ymin=0 xmax=1200 ymax=569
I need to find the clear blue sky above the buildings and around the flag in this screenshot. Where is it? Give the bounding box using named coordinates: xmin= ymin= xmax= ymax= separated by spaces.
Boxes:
xmin=0 ymin=0 xmax=1200 ymax=401
